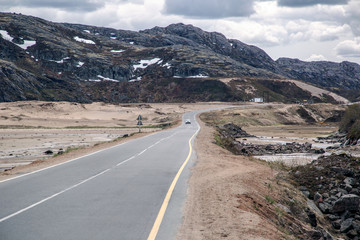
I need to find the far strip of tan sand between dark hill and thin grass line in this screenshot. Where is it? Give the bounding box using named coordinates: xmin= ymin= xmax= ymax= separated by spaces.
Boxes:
xmin=0 ymin=101 xmax=224 ymax=128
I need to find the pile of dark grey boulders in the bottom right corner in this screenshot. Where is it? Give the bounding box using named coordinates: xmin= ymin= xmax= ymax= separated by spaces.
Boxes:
xmin=292 ymin=154 xmax=360 ymax=239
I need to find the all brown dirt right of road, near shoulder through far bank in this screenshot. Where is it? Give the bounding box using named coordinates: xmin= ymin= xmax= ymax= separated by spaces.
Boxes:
xmin=177 ymin=104 xmax=350 ymax=240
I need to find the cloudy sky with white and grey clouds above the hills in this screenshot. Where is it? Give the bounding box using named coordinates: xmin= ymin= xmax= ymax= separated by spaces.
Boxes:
xmin=0 ymin=0 xmax=360 ymax=64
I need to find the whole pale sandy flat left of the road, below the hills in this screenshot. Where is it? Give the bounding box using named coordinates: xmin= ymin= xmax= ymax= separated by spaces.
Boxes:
xmin=0 ymin=101 xmax=231 ymax=179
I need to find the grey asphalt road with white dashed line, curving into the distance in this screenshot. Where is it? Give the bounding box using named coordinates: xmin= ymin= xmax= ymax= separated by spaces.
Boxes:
xmin=0 ymin=113 xmax=199 ymax=240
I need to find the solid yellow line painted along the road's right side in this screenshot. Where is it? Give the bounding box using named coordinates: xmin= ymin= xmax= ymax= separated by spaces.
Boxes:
xmin=147 ymin=130 xmax=199 ymax=240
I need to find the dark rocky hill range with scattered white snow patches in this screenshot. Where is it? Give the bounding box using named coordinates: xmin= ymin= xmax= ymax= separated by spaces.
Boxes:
xmin=0 ymin=13 xmax=360 ymax=102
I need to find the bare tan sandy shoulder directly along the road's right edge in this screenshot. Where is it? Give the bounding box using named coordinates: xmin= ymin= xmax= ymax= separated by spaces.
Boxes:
xmin=177 ymin=116 xmax=284 ymax=240
